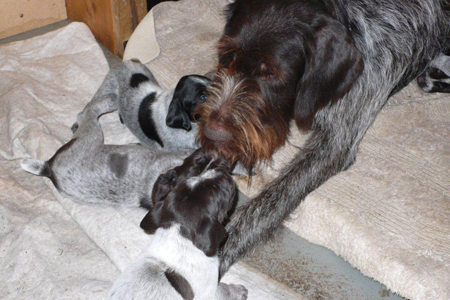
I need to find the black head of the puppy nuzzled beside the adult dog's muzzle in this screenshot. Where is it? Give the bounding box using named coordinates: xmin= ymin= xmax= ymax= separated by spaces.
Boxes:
xmin=166 ymin=75 xmax=210 ymax=131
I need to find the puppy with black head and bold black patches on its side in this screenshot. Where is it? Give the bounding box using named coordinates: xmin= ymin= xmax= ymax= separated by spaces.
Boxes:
xmin=72 ymin=59 xmax=210 ymax=151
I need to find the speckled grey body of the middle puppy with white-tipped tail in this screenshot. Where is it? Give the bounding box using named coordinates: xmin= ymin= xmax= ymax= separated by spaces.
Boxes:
xmin=21 ymin=105 xmax=187 ymax=208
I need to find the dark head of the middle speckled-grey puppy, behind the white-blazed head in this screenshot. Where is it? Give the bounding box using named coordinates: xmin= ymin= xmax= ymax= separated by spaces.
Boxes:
xmin=152 ymin=149 xmax=211 ymax=205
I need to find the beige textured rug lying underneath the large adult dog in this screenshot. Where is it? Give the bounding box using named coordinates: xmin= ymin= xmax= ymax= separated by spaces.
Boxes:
xmin=123 ymin=0 xmax=450 ymax=299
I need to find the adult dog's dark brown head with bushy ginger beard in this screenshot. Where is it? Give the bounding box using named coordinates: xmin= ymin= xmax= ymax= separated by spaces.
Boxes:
xmin=196 ymin=0 xmax=363 ymax=167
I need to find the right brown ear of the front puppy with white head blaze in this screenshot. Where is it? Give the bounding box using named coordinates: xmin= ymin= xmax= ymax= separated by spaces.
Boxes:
xmin=193 ymin=217 xmax=227 ymax=257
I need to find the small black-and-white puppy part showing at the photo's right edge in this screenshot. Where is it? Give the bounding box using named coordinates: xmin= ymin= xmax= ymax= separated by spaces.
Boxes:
xmin=417 ymin=53 xmax=450 ymax=93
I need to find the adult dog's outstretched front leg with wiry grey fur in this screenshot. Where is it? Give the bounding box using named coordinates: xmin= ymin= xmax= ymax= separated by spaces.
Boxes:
xmin=220 ymin=122 xmax=366 ymax=276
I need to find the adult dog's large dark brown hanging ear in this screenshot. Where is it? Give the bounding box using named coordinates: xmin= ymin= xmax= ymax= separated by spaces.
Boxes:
xmin=294 ymin=18 xmax=364 ymax=128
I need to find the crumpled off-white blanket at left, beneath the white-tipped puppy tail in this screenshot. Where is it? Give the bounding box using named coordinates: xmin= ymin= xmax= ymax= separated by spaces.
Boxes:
xmin=0 ymin=24 xmax=119 ymax=299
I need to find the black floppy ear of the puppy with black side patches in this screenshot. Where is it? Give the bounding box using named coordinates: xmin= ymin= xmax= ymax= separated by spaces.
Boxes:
xmin=166 ymin=76 xmax=192 ymax=131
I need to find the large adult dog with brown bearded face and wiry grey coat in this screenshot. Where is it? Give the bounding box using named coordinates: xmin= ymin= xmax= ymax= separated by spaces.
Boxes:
xmin=197 ymin=0 xmax=450 ymax=272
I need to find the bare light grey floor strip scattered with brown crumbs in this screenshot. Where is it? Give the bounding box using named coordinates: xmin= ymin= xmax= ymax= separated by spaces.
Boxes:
xmin=238 ymin=193 xmax=403 ymax=300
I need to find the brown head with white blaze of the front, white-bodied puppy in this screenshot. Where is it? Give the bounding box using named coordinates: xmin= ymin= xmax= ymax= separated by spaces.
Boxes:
xmin=141 ymin=159 xmax=236 ymax=256
